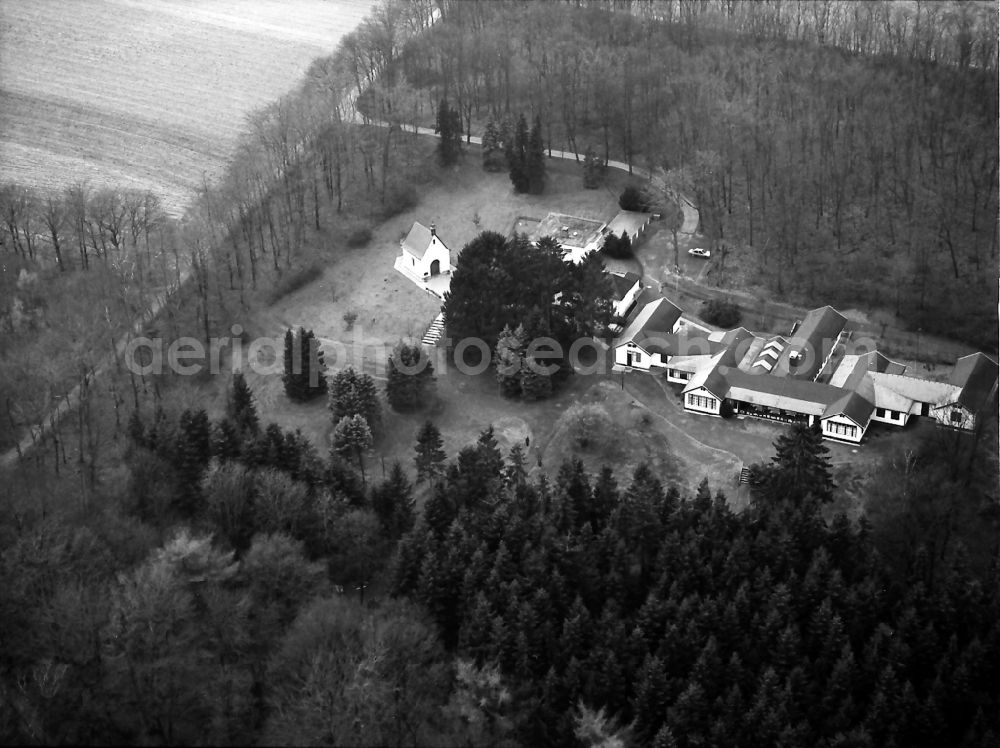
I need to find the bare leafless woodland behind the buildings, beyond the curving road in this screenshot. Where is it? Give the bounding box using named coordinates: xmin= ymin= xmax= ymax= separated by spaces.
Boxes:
xmin=386 ymin=0 xmax=998 ymax=350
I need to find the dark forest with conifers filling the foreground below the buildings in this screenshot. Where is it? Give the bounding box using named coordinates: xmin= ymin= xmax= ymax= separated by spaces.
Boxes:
xmin=0 ymin=377 xmax=1000 ymax=746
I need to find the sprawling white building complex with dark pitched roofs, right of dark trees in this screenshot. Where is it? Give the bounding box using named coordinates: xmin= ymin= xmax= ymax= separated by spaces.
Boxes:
xmin=615 ymin=299 xmax=998 ymax=443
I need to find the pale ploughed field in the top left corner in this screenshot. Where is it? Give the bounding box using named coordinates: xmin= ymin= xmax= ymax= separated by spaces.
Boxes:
xmin=0 ymin=0 xmax=372 ymax=215
